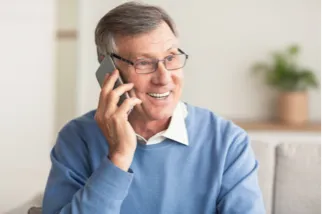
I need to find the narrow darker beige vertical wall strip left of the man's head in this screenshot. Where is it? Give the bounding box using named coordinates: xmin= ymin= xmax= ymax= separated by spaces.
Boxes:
xmin=55 ymin=0 xmax=78 ymax=132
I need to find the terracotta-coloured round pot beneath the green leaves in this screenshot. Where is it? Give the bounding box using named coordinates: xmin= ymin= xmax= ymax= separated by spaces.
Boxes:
xmin=278 ymin=91 xmax=308 ymax=125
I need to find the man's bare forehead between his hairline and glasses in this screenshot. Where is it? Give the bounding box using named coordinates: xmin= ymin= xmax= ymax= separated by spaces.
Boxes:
xmin=116 ymin=23 xmax=179 ymax=57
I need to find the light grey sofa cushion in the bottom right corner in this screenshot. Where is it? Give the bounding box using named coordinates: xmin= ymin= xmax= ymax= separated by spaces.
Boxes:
xmin=274 ymin=143 xmax=322 ymax=214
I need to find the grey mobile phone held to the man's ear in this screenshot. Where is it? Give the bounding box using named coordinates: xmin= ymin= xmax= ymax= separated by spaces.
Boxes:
xmin=96 ymin=56 xmax=130 ymax=106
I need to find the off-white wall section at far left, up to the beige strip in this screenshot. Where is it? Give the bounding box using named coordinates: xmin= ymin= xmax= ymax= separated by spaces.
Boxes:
xmin=0 ymin=0 xmax=55 ymax=214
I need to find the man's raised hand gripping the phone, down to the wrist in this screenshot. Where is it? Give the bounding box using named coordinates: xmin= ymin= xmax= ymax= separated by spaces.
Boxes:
xmin=94 ymin=70 xmax=142 ymax=171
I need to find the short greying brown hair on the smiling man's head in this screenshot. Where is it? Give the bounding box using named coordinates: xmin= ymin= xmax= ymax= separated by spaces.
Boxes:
xmin=95 ymin=1 xmax=178 ymax=62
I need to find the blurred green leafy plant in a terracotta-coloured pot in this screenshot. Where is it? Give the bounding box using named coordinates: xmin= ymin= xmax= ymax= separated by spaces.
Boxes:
xmin=252 ymin=45 xmax=319 ymax=125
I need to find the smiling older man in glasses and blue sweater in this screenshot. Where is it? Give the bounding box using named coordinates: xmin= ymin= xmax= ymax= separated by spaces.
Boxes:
xmin=43 ymin=2 xmax=265 ymax=214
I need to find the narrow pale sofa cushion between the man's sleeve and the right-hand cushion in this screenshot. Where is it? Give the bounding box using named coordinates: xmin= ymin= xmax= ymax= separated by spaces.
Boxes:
xmin=251 ymin=141 xmax=275 ymax=214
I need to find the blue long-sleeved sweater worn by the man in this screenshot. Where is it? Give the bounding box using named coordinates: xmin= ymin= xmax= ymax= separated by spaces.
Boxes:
xmin=43 ymin=105 xmax=265 ymax=214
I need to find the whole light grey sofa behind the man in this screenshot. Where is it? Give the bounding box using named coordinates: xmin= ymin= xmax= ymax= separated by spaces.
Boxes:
xmin=28 ymin=141 xmax=322 ymax=214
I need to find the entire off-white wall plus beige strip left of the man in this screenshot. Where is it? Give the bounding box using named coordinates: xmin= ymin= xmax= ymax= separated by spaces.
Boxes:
xmin=0 ymin=0 xmax=78 ymax=214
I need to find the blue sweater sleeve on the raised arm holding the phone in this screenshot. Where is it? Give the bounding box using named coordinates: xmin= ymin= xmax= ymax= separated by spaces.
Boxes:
xmin=43 ymin=121 xmax=133 ymax=214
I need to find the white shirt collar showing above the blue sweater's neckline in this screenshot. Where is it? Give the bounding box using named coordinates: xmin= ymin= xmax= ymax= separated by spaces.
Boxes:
xmin=137 ymin=101 xmax=189 ymax=145
